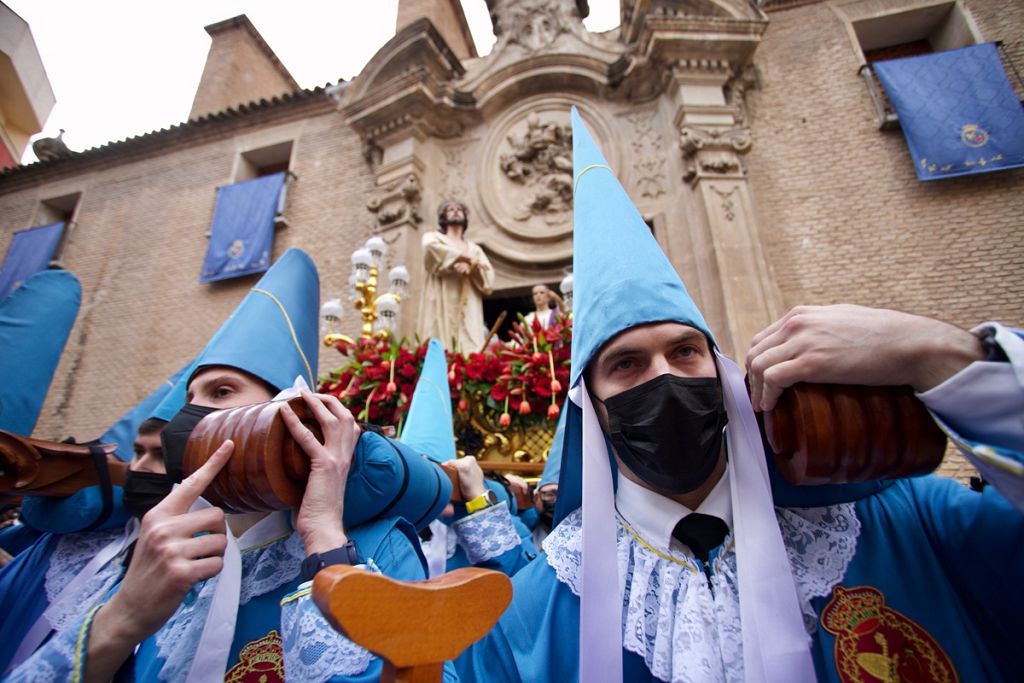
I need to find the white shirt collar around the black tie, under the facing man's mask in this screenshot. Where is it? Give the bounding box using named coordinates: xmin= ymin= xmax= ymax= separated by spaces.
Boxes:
xmin=615 ymin=464 xmax=732 ymax=549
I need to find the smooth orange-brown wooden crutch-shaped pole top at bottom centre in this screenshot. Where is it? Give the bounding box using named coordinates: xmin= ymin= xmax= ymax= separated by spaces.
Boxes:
xmin=312 ymin=564 xmax=512 ymax=683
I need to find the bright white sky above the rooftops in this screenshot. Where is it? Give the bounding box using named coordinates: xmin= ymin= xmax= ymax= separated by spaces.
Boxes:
xmin=9 ymin=0 xmax=618 ymax=163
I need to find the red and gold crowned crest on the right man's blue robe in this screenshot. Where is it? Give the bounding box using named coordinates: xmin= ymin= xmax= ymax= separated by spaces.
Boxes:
xmin=821 ymin=586 xmax=959 ymax=683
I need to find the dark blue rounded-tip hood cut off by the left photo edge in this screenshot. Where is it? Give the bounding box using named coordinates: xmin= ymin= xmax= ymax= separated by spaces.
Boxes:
xmin=0 ymin=270 xmax=82 ymax=436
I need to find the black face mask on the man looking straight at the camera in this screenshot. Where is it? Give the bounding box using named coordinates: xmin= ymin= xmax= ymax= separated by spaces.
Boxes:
xmin=598 ymin=374 xmax=729 ymax=494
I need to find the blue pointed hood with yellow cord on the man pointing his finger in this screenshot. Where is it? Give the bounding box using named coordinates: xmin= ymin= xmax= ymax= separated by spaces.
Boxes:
xmin=153 ymin=249 xmax=319 ymax=420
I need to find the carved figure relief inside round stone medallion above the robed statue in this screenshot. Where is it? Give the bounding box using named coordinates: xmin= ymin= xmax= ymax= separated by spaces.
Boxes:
xmin=499 ymin=114 xmax=572 ymax=223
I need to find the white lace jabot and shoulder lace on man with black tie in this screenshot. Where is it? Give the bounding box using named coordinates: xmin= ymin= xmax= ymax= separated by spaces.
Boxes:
xmin=544 ymin=503 xmax=860 ymax=683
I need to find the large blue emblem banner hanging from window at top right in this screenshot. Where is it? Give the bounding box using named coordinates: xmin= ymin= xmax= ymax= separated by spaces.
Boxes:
xmin=872 ymin=43 xmax=1024 ymax=180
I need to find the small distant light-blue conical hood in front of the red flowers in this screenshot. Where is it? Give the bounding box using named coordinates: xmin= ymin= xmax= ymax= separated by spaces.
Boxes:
xmin=401 ymin=339 xmax=456 ymax=462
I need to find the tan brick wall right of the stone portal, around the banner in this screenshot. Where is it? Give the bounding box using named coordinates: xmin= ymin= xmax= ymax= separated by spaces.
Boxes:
xmin=746 ymin=0 xmax=1024 ymax=477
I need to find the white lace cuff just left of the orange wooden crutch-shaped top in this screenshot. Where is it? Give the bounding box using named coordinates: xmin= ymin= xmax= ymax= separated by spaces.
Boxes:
xmin=281 ymin=588 xmax=373 ymax=682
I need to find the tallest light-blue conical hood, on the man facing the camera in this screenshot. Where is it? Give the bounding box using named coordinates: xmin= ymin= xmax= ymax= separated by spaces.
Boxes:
xmin=569 ymin=106 xmax=712 ymax=386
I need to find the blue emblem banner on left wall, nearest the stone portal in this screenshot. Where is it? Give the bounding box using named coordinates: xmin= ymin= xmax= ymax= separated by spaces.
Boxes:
xmin=199 ymin=172 xmax=285 ymax=283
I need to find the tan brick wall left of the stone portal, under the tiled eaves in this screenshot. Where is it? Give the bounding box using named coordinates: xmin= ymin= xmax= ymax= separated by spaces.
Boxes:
xmin=0 ymin=105 xmax=371 ymax=439
